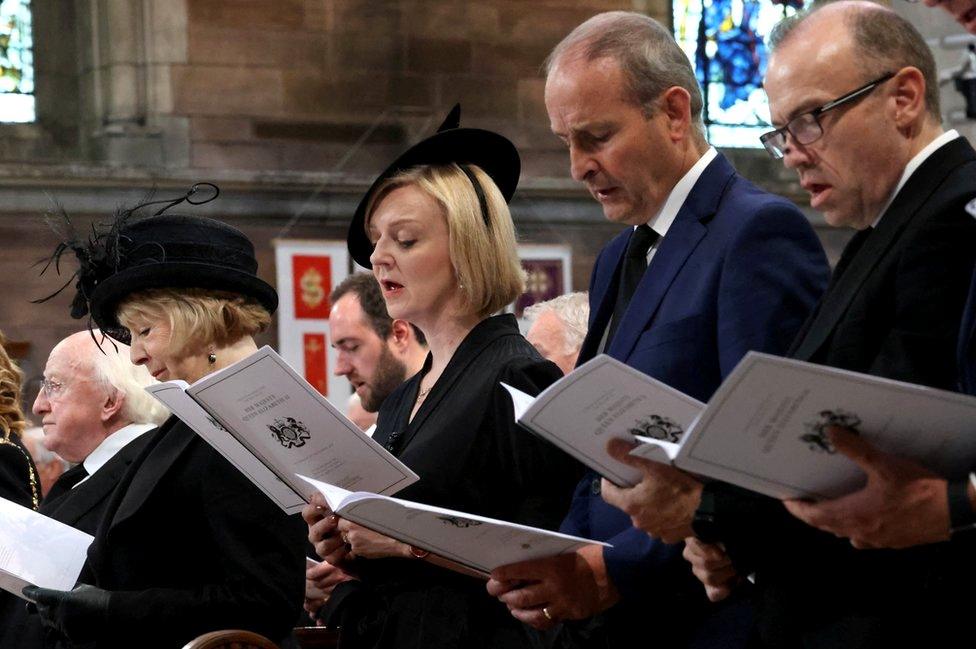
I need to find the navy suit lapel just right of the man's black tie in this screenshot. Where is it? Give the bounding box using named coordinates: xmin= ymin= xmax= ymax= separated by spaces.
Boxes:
xmin=607 ymin=154 xmax=735 ymax=361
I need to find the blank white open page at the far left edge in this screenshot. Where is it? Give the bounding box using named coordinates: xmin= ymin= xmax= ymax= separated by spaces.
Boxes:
xmin=0 ymin=498 xmax=94 ymax=599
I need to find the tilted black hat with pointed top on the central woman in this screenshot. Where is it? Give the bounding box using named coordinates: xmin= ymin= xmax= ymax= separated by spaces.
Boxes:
xmin=346 ymin=104 xmax=522 ymax=268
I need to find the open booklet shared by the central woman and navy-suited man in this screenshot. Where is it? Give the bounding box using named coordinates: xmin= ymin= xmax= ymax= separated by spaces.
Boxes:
xmin=299 ymin=476 xmax=610 ymax=576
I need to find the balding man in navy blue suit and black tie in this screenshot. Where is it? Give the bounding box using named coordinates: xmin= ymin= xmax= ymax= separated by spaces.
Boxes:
xmin=488 ymin=12 xmax=828 ymax=647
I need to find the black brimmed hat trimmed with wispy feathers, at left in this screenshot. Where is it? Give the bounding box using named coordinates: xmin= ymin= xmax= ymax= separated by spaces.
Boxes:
xmin=35 ymin=185 xmax=278 ymax=343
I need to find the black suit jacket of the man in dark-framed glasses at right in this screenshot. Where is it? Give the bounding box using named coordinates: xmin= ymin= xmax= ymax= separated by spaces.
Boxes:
xmin=706 ymin=138 xmax=976 ymax=649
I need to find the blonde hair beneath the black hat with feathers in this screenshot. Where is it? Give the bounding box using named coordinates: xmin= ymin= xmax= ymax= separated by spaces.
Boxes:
xmin=116 ymin=288 xmax=271 ymax=355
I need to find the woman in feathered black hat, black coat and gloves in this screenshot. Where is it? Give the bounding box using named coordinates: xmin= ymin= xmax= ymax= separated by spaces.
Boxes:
xmin=25 ymin=190 xmax=304 ymax=649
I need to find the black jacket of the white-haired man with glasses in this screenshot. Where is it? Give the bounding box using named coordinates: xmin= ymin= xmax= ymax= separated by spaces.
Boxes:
xmin=0 ymin=431 xmax=152 ymax=649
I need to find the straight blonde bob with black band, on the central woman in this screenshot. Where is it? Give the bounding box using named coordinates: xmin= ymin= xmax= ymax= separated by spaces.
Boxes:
xmin=364 ymin=163 xmax=525 ymax=318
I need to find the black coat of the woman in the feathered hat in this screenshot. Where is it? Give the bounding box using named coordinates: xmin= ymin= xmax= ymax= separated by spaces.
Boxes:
xmin=80 ymin=417 xmax=306 ymax=649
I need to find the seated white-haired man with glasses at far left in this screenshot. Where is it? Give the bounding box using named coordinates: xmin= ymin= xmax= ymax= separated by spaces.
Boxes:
xmin=0 ymin=331 xmax=168 ymax=649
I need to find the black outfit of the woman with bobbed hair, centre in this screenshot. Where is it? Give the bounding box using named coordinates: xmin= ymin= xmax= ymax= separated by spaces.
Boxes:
xmin=344 ymin=315 xmax=582 ymax=649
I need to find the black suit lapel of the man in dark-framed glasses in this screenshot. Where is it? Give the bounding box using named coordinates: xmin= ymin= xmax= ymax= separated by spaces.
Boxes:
xmin=790 ymin=138 xmax=972 ymax=360
